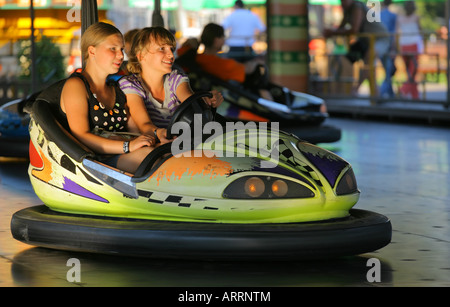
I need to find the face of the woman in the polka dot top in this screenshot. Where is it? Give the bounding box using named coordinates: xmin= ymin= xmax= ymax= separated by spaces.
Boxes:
xmin=89 ymin=34 xmax=124 ymax=74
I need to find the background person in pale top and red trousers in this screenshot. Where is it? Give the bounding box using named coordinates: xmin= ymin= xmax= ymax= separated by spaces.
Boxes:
xmin=397 ymin=1 xmax=423 ymax=99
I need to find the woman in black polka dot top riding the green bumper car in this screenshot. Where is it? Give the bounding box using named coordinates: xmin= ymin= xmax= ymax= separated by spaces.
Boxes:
xmin=60 ymin=22 xmax=156 ymax=173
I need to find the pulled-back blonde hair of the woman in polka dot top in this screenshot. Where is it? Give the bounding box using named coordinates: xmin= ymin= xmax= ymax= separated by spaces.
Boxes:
xmin=81 ymin=22 xmax=123 ymax=66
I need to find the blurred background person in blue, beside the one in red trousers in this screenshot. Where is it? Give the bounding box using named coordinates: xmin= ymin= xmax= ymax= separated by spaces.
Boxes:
xmin=380 ymin=0 xmax=397 ymax=98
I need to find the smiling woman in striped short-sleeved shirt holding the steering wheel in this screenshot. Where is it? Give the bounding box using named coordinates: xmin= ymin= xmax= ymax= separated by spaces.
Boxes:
xmin=119 ymin=27 xmax=223 ymax=143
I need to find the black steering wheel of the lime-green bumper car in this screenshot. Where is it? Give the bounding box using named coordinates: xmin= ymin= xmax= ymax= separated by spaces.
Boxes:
xmin=167 ymin=91 xmax=214 ymax=140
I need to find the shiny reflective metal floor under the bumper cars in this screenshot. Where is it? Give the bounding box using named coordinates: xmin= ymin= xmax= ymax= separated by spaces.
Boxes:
xmin=0 ymin=118 xmax=450 ymax=287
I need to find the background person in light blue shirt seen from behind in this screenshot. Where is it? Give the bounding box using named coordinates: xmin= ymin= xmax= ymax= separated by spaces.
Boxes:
xmin=222 ymin=0 xmax=266 ymax=62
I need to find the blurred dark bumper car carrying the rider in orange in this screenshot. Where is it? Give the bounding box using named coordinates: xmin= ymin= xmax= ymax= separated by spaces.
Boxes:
xmin=175 ymin=50 xmax=341 ymax=143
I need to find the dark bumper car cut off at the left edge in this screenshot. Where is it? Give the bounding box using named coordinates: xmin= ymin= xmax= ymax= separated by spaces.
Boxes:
xmin=0 ymin=99 xmax=30 ymax=158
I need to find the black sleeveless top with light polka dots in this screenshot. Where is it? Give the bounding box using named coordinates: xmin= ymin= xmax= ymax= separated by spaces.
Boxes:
xmin=72 ymin=73 xmax=128 ymax=132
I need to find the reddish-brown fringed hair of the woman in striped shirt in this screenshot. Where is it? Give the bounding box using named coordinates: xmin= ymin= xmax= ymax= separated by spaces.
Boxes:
xmin=127 ymin=27 xmax=177 ymax=74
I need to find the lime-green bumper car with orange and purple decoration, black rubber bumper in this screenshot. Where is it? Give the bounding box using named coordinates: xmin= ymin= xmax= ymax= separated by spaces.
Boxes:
xmin=11 ymin=85 xmax=391 ymax=261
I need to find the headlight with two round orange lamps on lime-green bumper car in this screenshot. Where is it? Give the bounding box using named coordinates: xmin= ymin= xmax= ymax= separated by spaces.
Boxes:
xmin=223 ymin=176 xmax=315 ymax=199
